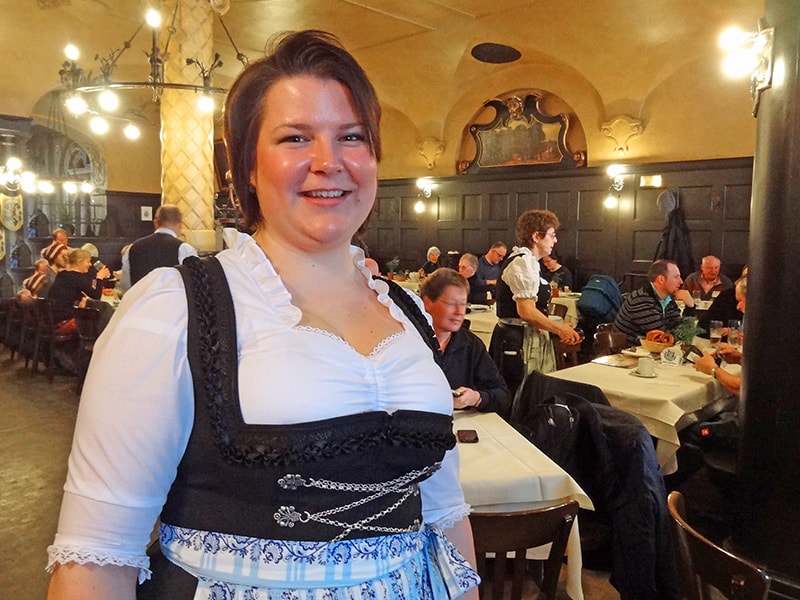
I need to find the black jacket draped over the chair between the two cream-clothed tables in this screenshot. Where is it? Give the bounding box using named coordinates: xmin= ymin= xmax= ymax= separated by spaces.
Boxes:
xmin=511 ymin=371 xmax=681 ymax=600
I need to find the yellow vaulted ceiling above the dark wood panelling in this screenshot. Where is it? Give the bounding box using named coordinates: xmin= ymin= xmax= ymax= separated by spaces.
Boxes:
xmin=0 ymin=0 xmax=764 ymax=189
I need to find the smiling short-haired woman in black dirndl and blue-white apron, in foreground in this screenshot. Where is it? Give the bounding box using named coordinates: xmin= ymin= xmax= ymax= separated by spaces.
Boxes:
xmin=45 ymin=31 xmax=478 ymax=600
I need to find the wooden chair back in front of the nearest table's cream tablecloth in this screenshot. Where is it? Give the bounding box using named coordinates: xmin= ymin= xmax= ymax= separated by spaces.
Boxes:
xmin=469 ymin=500 xmax=578 ymax=600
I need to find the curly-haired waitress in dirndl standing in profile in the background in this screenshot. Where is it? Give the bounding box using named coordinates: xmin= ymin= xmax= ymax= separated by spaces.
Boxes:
xmin=492 ymin=210 xmax=581 ymax=373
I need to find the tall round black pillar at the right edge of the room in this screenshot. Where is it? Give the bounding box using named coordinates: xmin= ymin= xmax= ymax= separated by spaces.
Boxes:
xmin=731 ymin=0 xmax=800 ymax=579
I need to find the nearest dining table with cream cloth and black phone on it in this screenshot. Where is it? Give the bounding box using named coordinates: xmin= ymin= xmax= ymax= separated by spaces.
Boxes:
xmin=453 ymin=410 xmax=594 ymax=600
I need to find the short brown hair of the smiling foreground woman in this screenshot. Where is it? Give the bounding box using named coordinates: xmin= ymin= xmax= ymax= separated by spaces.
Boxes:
xmin=224 ymin=30 xmax=381 ymax=229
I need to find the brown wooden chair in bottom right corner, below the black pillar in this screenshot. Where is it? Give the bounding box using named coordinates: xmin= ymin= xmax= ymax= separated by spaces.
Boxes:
xmin=667 ymin=492 xmax=770 ymax=600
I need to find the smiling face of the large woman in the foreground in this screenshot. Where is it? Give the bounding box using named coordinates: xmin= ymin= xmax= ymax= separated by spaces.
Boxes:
xmin=250 ymin=76 xmax=378 ymax=252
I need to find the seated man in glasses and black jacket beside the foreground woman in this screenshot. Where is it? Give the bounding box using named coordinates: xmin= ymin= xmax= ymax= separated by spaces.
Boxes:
xmin=420 ymin=269 xmax=511 ymax=418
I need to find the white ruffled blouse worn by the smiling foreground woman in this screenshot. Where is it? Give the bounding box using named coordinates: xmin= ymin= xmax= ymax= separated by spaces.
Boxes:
xmin=48 ymin=230 xmax=469 ymax=568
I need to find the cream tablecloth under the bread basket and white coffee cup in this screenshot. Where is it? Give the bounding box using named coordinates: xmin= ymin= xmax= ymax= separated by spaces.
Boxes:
xmin=550 ymin=362 xmax=723 ymax=474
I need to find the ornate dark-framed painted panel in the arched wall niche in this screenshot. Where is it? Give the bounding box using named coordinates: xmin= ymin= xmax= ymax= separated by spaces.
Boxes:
xmin=459 ymin=93 xmax=586 ymax=173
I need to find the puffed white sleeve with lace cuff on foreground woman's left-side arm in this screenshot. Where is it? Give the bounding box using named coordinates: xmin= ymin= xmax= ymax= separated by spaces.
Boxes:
xmin=48 ymin=269 xmax=194 ymax=579
